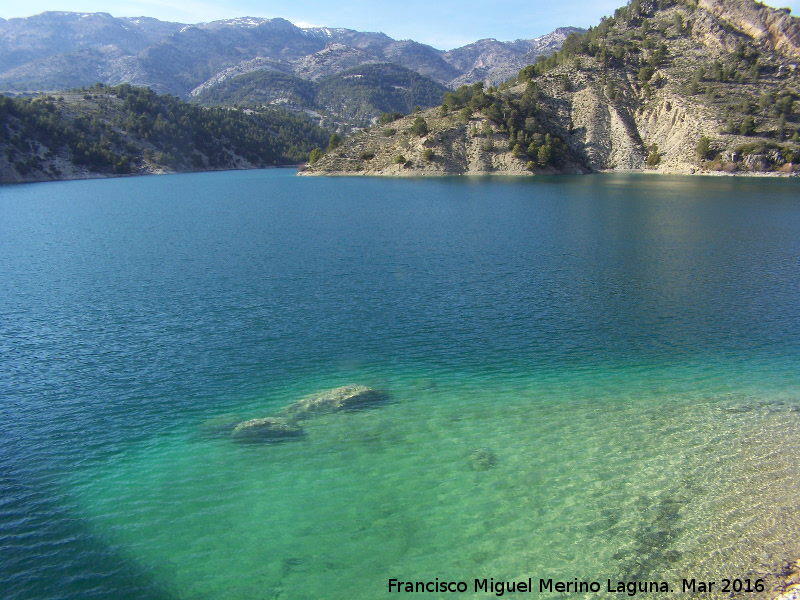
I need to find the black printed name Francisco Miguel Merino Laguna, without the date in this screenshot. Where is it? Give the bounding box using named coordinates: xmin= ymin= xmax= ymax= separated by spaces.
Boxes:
xmin=389 ymin=577 xmax=671 ymax=596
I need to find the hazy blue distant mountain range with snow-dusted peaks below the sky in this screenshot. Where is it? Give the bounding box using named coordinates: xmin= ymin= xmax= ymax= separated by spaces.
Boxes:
xmin=0 ymin=12 xmax=582 ymax=99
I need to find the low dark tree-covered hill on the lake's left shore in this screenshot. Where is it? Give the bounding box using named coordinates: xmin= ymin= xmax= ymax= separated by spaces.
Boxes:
xmin=0 ymin=84 xmax=330 ymax=183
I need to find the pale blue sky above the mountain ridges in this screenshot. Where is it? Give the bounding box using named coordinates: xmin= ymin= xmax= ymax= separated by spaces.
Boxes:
xmin=0 ymin=0 xmax=800 ymax=50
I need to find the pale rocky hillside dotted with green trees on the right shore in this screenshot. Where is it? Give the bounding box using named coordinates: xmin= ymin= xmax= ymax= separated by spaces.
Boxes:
xmin=305 ymin=0 xmax=800 ymax=175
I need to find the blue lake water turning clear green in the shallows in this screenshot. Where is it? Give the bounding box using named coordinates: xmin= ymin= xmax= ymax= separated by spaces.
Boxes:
xmin=0 ymin=171 xmax=800 ymax=599
